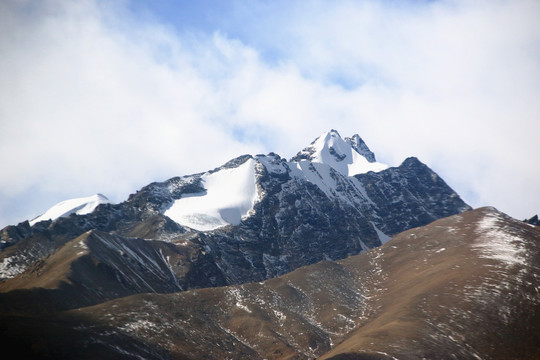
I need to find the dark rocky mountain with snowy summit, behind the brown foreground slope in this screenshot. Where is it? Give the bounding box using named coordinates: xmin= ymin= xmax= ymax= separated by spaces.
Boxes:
xmin=0 ymin=130 xmax=470 ymax=308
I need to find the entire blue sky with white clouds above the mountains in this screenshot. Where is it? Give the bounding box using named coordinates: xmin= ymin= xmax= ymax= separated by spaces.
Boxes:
xmin=0 ymin=0 xmax=540 ymax=227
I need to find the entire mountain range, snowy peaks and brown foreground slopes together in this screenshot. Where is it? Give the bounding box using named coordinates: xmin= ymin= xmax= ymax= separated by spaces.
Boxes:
xmin=0 ymin=130 xmax=540 ymax=359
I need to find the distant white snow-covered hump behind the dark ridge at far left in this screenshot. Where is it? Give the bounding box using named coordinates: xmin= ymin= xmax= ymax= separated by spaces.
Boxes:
xmin=30 ymin=194 xmax=109 ymax=226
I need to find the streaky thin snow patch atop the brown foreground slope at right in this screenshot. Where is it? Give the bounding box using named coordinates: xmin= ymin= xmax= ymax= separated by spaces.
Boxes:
xmin=473 ymin=214 xmax=526 ymax=266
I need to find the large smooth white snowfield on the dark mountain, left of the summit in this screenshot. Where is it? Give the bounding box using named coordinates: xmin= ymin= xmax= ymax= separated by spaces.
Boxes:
xmin=165 ymin=159 xmax=258 ymax=231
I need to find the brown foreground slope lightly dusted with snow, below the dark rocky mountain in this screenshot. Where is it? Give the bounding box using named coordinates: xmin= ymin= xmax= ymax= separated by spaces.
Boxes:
xmin=0 ymin=208 xmax=540 ymax=360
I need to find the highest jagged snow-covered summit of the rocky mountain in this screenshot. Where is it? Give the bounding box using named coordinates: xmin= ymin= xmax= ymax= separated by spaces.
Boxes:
xmin=291 ymin=129 xmax=388 ymax=176
